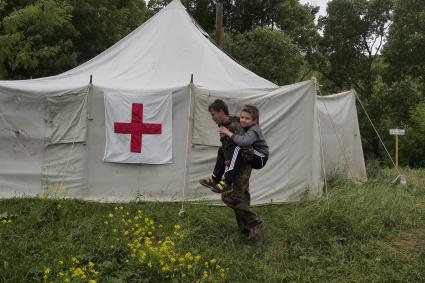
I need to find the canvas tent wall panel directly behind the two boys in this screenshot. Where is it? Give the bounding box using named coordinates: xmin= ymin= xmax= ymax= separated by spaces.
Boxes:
xmin=187 ymin=81 xmax=322 ymax=204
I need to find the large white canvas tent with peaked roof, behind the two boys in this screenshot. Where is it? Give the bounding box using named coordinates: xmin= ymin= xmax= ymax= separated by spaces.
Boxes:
xmin=0 ymin=0 xmax=364 ymax=204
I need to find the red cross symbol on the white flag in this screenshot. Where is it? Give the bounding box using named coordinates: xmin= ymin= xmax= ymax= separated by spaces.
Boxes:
xmin=114 ymin=103 xmax=162 ymax=153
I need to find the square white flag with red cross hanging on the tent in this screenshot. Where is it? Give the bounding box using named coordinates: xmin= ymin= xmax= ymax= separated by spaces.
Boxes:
xmin=103 ymin=93 xmax=172 ymax=164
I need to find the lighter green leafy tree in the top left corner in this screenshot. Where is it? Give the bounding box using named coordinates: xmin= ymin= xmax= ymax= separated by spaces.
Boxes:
xmin=0 ymin=0 xmax=78 ymax=79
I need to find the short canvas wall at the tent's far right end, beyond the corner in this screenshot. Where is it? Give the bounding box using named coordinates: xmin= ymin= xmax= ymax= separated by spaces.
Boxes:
xmin=317 ymin=90 xmax=367 ymax=182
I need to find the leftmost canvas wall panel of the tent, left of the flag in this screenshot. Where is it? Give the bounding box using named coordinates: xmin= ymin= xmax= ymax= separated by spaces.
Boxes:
xmin=0 ymin=87 xmax=88 ymax=197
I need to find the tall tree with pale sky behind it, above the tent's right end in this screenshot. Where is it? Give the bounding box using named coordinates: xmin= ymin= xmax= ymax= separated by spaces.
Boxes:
xmin=317 ymin=0 xmax=392 ymax=98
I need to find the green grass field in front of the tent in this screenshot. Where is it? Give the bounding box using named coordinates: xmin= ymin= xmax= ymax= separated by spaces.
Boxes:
xmin=0 ymin=169 xmax=425 ymax=282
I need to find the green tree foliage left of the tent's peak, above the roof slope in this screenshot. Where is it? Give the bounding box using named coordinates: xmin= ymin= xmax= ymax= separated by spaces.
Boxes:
xmin=0 ymin=0 xmax=146 ymax=79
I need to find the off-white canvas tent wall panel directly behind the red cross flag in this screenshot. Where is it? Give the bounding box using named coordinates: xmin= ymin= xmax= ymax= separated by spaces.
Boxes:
xmin=83 ymin=86 xmax=189 ymax=201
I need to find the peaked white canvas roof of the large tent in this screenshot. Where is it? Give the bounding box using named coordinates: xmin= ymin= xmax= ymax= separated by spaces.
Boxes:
xmin=0 ymin=0 xmax=276 ymax=91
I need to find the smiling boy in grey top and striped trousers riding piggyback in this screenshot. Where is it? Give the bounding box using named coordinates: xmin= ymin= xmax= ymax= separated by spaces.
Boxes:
xmin=213 ymin=105 xmax=269 ymax=192
